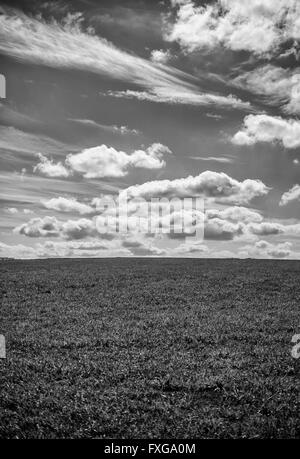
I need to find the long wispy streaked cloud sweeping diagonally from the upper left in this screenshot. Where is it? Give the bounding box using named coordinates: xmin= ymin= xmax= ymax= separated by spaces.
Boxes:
xmin=0 ymin=9 xmax=249 ymax=109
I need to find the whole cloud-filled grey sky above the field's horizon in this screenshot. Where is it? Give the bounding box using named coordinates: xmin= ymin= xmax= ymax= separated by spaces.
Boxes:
xmin=0 ymin=0 xmax=300 ymax=259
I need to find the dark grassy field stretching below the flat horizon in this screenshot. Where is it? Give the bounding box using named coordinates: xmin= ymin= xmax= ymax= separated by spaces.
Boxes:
xmin=0 ymin=259 xmax=300 ymax=438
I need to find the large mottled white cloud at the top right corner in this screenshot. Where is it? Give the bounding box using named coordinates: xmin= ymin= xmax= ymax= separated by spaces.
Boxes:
xmin=165 ymin=0 xmax=300 ymax=58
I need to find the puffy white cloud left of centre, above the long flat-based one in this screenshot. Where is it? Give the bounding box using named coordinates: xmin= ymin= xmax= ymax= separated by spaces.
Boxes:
xmin=33 ymin=143 xmax=171 ymax=178
